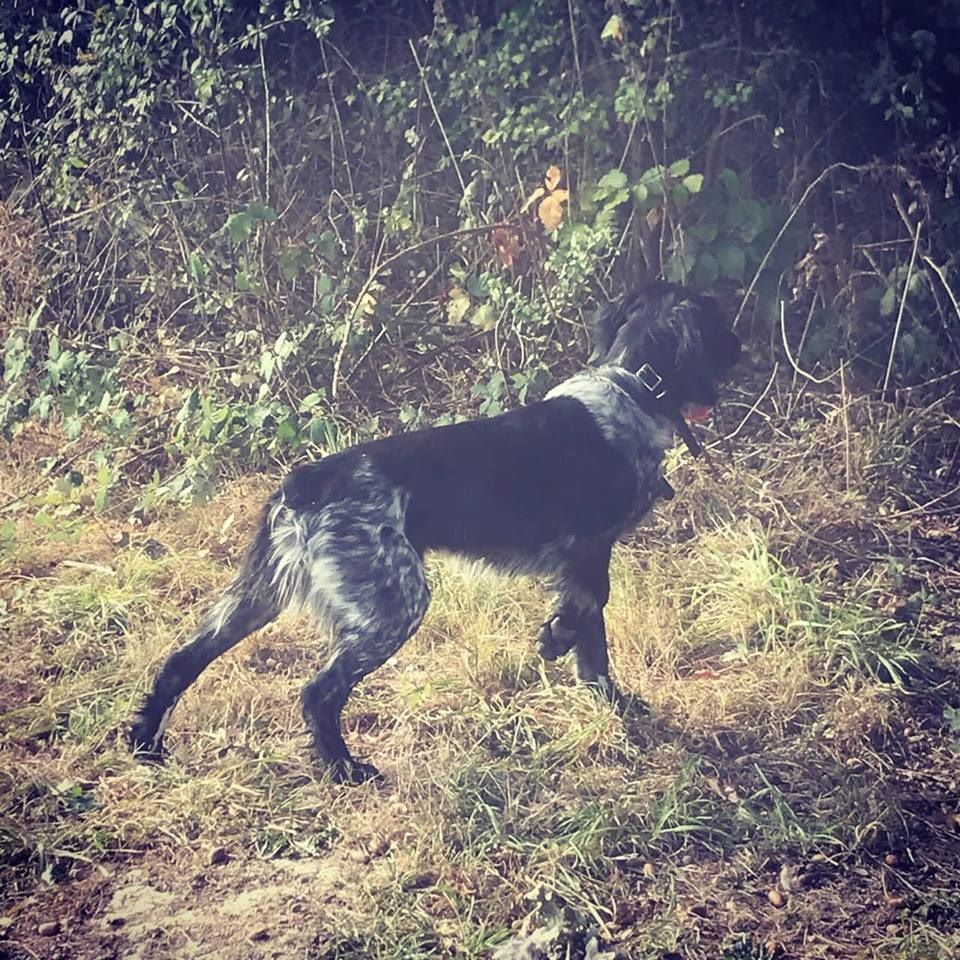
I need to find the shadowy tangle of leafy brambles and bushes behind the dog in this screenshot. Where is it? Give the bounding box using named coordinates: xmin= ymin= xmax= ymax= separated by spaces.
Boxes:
xmin=0 ymin=0 xmax=960 ymax=498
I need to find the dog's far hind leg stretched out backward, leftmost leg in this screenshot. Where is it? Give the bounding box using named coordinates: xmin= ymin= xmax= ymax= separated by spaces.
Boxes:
xmin=128 ymin=527 xmax=282 ymax=760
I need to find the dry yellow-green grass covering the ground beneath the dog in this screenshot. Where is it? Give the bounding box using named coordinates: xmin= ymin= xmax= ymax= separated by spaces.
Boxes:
xmin=0 ymin=384 xmax=960 ymax=960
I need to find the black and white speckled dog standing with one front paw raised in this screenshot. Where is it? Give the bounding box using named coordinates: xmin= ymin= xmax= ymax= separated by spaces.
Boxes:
xmin=130 ymin=282 xmax=740 ymax=782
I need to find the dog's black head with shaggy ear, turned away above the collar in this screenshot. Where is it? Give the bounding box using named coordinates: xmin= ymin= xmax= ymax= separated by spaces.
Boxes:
xmin=590 ymin=281 xmax=740 ymax=419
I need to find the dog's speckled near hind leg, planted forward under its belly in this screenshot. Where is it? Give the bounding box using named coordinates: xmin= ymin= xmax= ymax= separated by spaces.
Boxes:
xmin=301 ymin=514 xmax=430 ymax=783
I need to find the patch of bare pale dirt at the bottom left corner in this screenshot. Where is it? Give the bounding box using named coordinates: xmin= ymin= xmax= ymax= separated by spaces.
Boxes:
xmin=6 ymin=853 xmax=376 ymax=960
